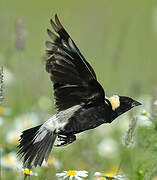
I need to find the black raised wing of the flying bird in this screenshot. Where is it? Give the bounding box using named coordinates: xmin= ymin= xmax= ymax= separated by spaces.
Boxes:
xmin=46 ymin=15 xmax=105 ymax=110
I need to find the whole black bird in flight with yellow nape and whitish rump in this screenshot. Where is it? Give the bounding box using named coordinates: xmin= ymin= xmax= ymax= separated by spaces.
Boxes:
xmin=18 ymin=15 xmax=141 ymax=167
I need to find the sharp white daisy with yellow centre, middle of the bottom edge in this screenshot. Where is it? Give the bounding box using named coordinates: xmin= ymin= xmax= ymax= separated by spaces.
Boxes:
xmin=56 ymin=170 xmax=88 ymax=180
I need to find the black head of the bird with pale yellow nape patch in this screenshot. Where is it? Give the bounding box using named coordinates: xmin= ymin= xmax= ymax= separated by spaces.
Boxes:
xmin=107 ymin=95 xmax=141 ymax=120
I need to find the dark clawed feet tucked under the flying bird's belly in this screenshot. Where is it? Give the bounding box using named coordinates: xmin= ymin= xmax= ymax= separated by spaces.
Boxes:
xmin=55 ymin=134 xmax=76 ymax=147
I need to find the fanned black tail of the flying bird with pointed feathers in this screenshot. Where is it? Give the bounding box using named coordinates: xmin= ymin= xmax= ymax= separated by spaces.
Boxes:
xmin=18 ymin=125 xmax=57 ymax=167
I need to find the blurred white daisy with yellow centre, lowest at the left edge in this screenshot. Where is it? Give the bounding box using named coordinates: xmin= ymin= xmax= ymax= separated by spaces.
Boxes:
xmin=1 ymin=152 xmax=22 ymax=169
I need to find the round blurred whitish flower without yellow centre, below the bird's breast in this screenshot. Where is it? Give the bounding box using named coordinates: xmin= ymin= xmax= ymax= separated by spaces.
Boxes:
xmin=98 ymin=138 xmax=118 ymax=157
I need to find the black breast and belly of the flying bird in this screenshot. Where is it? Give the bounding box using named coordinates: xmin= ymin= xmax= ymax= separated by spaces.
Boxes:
xmin=64 ymin=104 xmax=111 ymax=134
